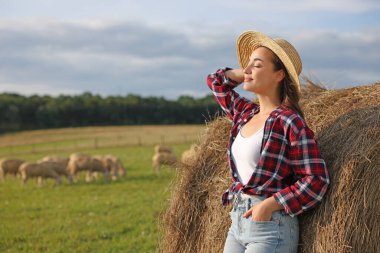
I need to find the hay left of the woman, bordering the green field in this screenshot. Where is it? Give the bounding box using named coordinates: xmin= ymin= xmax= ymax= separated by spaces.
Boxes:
xmin=160 ymin=118 xmax=231 ymax=253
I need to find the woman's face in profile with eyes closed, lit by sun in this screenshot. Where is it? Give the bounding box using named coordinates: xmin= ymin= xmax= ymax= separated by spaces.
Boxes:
xmin=243 ymin=47 xmax=284 ymax=95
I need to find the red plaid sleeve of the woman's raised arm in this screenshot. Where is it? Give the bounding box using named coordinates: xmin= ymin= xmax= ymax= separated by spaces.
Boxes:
xmin=207 ymin=68 xmax=252 ymax=119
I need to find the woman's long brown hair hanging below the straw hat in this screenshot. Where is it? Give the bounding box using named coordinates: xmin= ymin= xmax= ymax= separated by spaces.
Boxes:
xmin=273 ymin=53 xmax=304 ymax=118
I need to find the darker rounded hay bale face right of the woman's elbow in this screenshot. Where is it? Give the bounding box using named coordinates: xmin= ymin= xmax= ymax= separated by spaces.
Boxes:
xmin=299 ymin=106 xmax=380 ymax=253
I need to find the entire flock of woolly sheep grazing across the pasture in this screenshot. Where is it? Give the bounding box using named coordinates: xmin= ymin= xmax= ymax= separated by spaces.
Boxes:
xmin=0 ymin=145 xmax=198 ymax=185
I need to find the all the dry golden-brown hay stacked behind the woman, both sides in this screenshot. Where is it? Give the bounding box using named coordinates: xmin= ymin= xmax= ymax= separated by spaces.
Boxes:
xmin=160 ymin=84 xmax=380 ymax=253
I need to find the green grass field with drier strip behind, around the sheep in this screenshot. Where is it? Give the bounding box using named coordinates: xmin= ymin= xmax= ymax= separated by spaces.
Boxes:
xmin=0 ymin=126 xmax=203 ymax=252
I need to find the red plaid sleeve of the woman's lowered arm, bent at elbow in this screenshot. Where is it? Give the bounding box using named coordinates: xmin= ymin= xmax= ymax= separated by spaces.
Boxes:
xmin=273 ymin=118 xmax=330 ymax=216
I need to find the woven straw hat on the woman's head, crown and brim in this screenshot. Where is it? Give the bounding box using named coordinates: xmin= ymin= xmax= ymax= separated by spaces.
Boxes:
xmin=236 ymin=31 xmax=302 ymax=92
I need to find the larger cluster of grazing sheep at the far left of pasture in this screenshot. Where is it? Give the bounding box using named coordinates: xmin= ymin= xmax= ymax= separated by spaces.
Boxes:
xmin=0 ymin=154 xmax=126 ymax=185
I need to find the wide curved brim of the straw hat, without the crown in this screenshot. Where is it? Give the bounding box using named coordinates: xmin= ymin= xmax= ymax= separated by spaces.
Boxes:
xmin=236 ymin=30 xmax=301 ymax=92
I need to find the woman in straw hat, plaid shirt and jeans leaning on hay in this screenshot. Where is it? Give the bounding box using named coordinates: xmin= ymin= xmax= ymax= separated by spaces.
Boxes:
xmin=207 ymin=31 xmax=329 ymax=253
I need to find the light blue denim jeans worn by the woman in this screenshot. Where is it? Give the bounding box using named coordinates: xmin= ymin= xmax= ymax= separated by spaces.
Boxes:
xmin=223 ymin=195 xmax=299 ymax=253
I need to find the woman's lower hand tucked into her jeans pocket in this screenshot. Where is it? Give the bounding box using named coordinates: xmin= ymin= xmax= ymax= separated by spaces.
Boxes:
xmin=243 ymin=197 xmax=282 ymax=221
